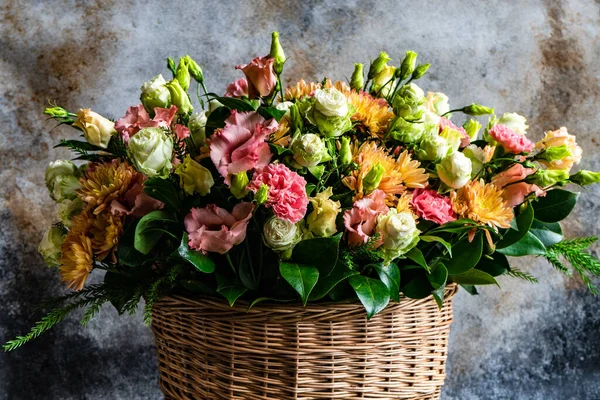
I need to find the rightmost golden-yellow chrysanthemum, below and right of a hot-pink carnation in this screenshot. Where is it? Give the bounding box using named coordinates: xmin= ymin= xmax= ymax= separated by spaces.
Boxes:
xmin=450 ymin=179 xmax=514 ymax=228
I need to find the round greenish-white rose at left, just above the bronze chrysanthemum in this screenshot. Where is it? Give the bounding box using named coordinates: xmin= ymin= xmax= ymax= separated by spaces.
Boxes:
xmin=127 ymin=128 xmax=173 ymax=178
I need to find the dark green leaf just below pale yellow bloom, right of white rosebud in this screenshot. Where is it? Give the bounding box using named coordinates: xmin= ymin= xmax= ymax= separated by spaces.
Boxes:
xmin=292 ymin=233 xmax=342 ymax=276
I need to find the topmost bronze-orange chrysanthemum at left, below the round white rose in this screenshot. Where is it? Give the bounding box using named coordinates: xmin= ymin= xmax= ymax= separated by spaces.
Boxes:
xmin=77 ymin=160 xmax=141 ymax=214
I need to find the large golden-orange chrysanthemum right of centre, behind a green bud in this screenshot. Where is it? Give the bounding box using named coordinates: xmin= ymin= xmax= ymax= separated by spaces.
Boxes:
xmin=342 ymin=142 xmax=429 ymax=205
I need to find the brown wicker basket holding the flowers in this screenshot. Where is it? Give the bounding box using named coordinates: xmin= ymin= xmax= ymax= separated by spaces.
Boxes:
xmin=152 ymin=285 xmax=456 ymax=400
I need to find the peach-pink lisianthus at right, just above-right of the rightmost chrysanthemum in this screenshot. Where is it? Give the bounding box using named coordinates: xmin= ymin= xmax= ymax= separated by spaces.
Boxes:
xmin=492 ymin=164 xmax=545 ymax=207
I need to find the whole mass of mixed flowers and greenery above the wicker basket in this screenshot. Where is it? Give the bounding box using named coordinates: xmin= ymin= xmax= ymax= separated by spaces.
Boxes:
xmin=4 ymin=33 xmax=600 ymax=350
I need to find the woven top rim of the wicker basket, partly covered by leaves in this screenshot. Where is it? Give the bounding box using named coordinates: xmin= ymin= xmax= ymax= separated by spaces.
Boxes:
xmin=154 ymin=283 xmax=458 ymax=314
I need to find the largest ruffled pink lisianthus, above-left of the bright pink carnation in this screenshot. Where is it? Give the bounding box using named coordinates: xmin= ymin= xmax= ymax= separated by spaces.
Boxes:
xmin=209 ymin=111 xmax=278 ymax=185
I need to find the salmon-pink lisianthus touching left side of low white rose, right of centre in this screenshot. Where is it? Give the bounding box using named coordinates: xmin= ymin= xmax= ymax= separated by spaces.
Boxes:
xmin=344 ymin=189 xmax=389 ymax=246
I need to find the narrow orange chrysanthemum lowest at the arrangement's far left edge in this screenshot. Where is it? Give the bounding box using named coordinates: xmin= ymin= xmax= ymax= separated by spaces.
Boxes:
xmin=60 ymin=211 xmax=94 ymax=290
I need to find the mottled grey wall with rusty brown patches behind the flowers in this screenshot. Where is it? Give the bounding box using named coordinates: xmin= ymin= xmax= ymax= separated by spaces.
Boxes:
xmin=0 ymin=0 xmax=600 ymax=400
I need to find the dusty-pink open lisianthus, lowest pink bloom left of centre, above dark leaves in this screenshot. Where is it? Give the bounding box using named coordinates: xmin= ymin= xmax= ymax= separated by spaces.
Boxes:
xmin=183 ymin=202 xmax=254 ymax=254
